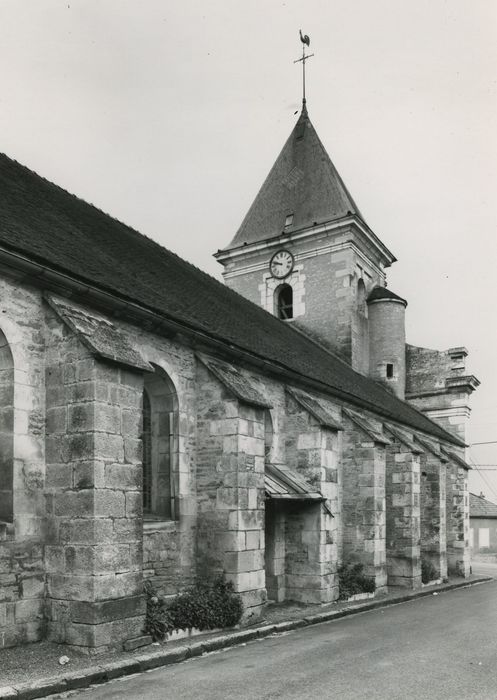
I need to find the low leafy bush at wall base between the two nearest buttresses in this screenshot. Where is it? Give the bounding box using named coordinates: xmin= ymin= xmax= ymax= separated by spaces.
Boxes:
xmin=145 ymin=576 xmax=243 ymax=641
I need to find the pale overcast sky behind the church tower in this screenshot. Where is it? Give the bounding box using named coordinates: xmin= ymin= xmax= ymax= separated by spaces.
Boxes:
xmin=0 ymin=0 xmax=497 ymax=502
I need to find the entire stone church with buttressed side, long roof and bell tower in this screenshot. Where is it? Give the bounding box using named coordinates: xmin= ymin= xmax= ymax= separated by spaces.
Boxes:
xmin=0 ymin=93 xmax=478 ymax=652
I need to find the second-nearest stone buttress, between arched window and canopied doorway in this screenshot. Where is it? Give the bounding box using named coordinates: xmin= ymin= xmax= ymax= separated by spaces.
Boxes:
xmin=197 ymin=356 xmax=268 ymax=618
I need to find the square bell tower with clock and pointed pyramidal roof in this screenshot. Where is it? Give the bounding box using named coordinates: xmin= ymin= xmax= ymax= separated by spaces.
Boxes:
xmin=214 ymin=99 xmax=395 ymax=374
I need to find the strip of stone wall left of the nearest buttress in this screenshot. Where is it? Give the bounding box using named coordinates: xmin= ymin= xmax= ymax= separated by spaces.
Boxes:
xmin=0 ymin=278 xmax=46 ymax=647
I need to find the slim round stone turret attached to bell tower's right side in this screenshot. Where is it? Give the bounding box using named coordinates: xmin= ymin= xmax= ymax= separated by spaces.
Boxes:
xmin=367 ymin=287 xmax=407 ymax=399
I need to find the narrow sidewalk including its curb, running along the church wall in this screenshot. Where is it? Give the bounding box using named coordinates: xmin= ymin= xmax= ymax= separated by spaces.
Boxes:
xmin=0 ymin=576 xmax=494 ymax=700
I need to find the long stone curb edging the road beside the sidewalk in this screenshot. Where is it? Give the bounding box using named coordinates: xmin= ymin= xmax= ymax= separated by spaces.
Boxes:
xmin=0 ymin=576 xmax=488 ymax=700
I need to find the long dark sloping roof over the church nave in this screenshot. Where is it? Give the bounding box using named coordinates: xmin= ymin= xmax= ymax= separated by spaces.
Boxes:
xmin=0 ymin=154 xmax=462 ymax=444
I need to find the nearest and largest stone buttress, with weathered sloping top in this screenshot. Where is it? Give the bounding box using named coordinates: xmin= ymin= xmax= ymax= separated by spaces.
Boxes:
xmin=45 ymin=300 xmax=147 ymax=652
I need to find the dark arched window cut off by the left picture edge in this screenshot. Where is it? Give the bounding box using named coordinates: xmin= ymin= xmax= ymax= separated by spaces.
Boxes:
xmin=0 ymin=331 xmax=14 ymax=523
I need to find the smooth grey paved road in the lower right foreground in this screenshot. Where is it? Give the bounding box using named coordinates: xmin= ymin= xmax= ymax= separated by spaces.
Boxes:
xmin=70 ymin=581 xmax=497 ymax=700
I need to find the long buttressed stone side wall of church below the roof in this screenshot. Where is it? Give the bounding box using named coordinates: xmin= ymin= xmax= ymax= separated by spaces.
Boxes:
xmin=0 ymin=280 xmax=469 ymax=650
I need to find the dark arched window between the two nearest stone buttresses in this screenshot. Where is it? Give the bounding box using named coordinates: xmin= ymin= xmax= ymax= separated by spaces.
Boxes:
xmin=143 ymin=367 xmax=178 ymax=520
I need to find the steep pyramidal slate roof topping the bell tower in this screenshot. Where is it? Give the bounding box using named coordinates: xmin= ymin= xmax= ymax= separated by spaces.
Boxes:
xmin=225 ymin=106 xmax=363 ymax=250
